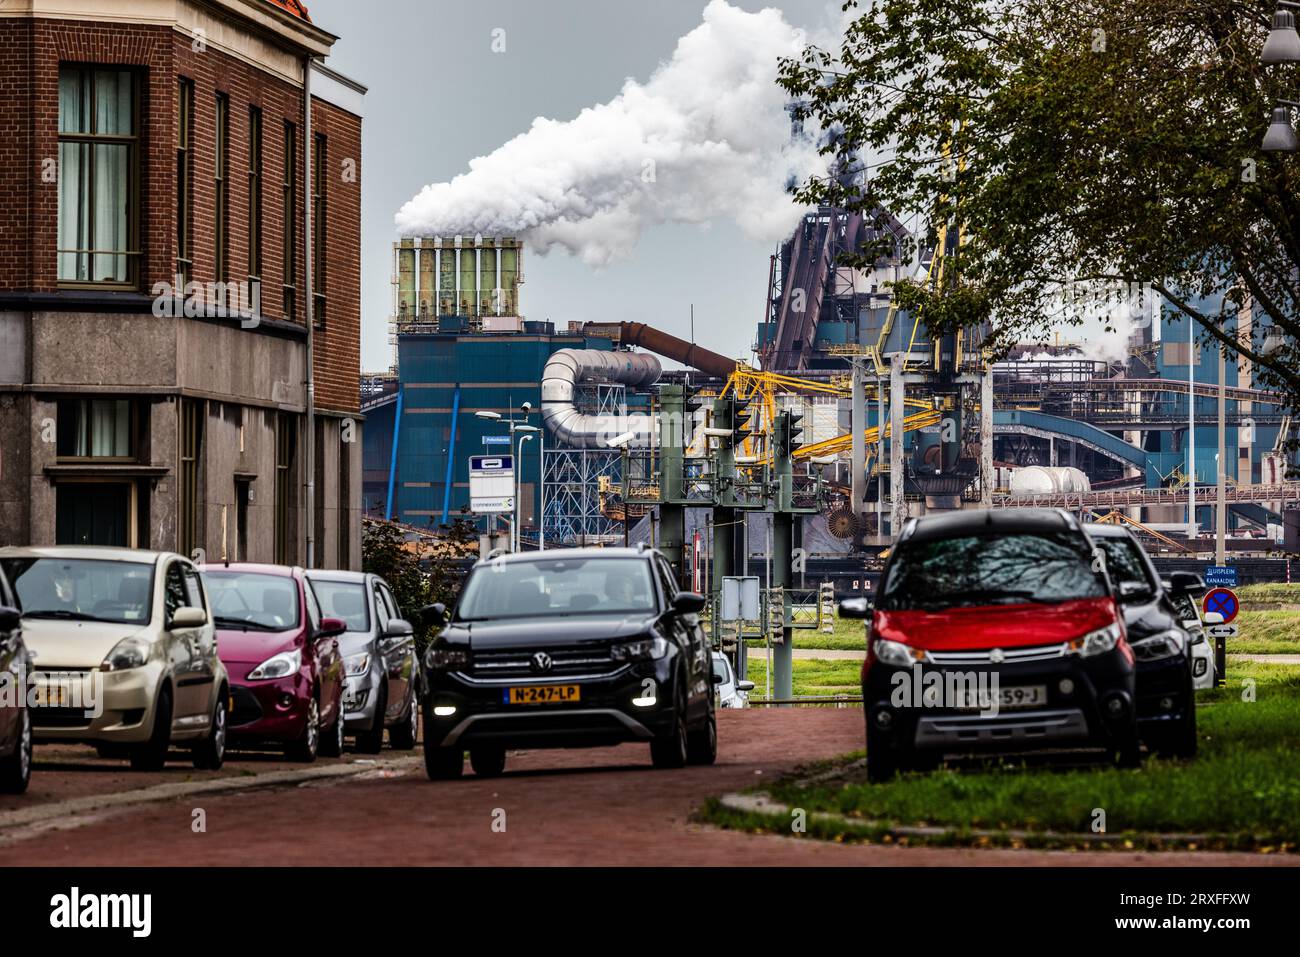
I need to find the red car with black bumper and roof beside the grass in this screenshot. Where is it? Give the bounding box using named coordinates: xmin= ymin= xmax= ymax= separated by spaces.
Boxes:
xmin=840 ymin=508 xmax=1139 ymax=780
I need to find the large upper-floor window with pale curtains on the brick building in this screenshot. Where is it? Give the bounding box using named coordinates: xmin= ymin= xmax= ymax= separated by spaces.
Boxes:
xmin=57 ymin=64 xmax=139 ymax=286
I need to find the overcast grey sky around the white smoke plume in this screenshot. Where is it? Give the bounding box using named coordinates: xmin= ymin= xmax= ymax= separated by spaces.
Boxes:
xmin=308 ymin=0 xmax=840 ymax=371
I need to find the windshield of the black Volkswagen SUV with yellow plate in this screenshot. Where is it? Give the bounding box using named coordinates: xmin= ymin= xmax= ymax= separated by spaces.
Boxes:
xmin=456 ymin=558 xmax=655 ymax=622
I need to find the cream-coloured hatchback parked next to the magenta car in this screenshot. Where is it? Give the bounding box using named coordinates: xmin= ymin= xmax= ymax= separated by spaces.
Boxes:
xmin=0 ymin=546 xmax=229 ymax=771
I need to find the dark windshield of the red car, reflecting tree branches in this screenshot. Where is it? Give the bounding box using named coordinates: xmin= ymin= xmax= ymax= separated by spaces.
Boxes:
xmin=876 ymin=532 xmax=1106 ymax=610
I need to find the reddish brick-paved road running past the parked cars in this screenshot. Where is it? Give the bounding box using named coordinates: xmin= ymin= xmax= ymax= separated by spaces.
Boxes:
xmin=0 ymin=709 xmax=1300 ymax=866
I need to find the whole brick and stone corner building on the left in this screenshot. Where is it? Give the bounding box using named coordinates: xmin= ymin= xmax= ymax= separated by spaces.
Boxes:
xmin=0 ymin=0 xmax=365 ymax=567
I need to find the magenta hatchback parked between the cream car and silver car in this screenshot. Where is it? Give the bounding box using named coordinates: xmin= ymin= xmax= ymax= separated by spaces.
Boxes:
xmin=202 ymin=564 xmax=347 ymax=761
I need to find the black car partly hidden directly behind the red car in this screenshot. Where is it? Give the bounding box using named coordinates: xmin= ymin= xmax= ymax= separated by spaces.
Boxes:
xmin=1086 ymin=524 xmax=1201 ymax=758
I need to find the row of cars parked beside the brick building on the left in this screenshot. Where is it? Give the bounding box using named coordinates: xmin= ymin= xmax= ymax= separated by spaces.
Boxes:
xmin=0 ymin=546 xmax=419 ymax=792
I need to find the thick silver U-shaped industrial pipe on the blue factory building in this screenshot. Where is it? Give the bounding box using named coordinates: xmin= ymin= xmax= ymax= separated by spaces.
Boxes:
xmin=542 ymin=348 xmax=662 ymax=449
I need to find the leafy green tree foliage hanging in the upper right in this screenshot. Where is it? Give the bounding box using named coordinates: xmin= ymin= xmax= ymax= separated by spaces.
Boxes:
xmin=780 ymin=0 xmax=1300 ymax=397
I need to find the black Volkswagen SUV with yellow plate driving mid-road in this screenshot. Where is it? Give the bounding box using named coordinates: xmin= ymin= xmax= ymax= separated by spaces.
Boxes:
xmin=421 ymin=549 xmax=718 ymax=780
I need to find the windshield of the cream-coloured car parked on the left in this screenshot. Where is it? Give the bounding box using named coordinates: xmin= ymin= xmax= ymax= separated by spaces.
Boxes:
xmin=4 ymin=558 xmax=153 ymax=624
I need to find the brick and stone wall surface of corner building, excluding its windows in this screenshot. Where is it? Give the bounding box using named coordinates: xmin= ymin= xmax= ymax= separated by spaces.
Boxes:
xmin=0 ymin=0 xmax=361 ymax=567
